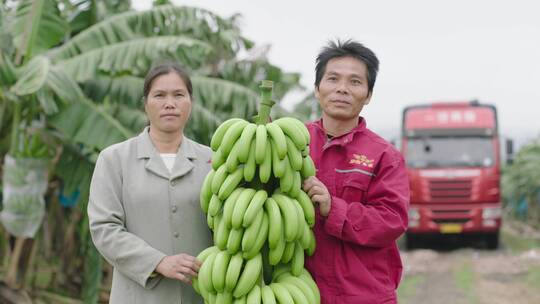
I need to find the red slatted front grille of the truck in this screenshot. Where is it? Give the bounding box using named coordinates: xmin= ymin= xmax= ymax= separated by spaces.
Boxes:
xmin=429 ymin=180 xmax=472 ymax=203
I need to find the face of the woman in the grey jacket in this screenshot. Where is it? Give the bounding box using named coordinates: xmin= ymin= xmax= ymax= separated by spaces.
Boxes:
xmin=144 ymin=72 xmax=191 ymax=133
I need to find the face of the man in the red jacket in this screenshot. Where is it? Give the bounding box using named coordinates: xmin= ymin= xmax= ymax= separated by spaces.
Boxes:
xmin=315 ymin=57 xmax=371 ymax=121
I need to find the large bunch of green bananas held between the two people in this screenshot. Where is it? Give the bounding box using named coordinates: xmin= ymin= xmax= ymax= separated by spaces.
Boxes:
xmin=193 ymin=81 xmax=320 ymax=304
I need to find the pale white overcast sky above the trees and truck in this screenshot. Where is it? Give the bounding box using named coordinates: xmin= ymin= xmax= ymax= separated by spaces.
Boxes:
xmin=133 ymin=0 xmax=540 ymax=145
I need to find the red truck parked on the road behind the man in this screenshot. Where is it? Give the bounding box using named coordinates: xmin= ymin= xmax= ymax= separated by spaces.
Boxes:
xmin=401 ymin=101 xmax=511 ymax=249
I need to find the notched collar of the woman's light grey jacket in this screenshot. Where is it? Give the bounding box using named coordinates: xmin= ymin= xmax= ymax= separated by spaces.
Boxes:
xmin=137 ymin=127 xmax=197 ymax=180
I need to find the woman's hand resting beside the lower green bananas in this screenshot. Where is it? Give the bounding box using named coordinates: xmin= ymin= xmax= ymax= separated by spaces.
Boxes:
xmin=156 ymin=253 xmax=202 ymax=284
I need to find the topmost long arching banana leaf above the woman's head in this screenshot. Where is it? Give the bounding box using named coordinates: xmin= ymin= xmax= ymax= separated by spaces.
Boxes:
xmin=50 ymin=5 xmax=245 ymax=60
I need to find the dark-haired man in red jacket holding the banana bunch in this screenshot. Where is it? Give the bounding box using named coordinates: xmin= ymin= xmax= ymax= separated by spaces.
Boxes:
xmin=303 ymin=41 xmax=409 ymax=304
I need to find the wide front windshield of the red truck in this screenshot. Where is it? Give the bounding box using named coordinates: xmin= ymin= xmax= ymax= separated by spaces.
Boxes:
xmin=406 ymin=137 xmax=495 ymax=168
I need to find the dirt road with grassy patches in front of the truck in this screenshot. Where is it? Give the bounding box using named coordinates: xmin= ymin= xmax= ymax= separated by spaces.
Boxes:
xmin=398 ymin=222 xmax=540 ymax=304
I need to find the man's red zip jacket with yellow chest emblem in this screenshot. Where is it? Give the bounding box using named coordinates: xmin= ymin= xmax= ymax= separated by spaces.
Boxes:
xmin=306 ymin=118 xmax=409 ymax=304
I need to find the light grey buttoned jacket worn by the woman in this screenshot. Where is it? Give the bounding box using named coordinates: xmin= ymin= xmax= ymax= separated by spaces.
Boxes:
xmin=88 ymin=128 xmax=212 ymax=304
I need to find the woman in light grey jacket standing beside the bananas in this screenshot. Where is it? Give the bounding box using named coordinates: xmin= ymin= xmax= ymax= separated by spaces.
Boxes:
xmin=88 ymin=64 xmax=212 ymax=304
